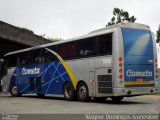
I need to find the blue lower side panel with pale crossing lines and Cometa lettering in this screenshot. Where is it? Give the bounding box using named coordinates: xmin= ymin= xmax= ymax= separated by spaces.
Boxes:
xmin=10 ymin=62 xmax=72 ymax=94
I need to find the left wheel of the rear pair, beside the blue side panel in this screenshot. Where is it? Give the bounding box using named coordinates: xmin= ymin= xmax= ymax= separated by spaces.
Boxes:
xmin=63 ymin=82 xmax=76 ymax=101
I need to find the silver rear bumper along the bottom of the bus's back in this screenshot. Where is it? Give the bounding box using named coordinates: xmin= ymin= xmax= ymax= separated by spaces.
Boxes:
xmin=113 ymin=87 xmax=158 ymax=96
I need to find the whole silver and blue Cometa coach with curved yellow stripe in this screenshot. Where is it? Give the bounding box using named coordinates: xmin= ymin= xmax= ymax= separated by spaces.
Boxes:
xmin=2 ymin=23 xmax=158 ymax=102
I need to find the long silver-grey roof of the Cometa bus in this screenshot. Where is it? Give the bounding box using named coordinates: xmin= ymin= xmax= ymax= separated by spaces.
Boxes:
xmin=4 ymin=23 xmax=150 ymax=56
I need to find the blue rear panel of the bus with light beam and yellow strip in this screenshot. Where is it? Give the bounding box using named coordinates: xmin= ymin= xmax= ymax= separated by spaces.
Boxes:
xmin=122 ymin=28 xmax=155 ymax=87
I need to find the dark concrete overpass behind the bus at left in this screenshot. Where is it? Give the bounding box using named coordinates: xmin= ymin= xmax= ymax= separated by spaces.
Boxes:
xmin=0 ymin=21 xmax=51 ymax=59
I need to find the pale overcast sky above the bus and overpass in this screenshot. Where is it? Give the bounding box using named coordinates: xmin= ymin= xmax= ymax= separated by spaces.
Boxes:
xmin=0 ymin=0 xmax=160 ymax=39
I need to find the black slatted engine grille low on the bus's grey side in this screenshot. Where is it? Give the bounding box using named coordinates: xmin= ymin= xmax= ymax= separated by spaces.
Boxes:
xmin=98 ymin=75 xmax=113 ymax=94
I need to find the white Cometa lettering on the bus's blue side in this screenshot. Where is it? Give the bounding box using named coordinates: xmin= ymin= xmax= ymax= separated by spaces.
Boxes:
xmin=22 ymin=67 xmax=40 ymax=75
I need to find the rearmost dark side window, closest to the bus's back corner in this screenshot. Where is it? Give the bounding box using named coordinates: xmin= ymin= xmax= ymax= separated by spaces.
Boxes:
xmin=97 ymin=33 xmax=112 ymax=55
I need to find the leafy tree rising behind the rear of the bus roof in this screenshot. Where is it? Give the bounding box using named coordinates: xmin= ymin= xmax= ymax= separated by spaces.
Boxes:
xmin=106 ymin=8 xmax=136 ymax=26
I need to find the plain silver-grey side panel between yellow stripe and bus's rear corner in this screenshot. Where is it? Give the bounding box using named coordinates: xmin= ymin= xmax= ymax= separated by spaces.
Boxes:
xmin=67 ymin=55 xmax=113 ymax=97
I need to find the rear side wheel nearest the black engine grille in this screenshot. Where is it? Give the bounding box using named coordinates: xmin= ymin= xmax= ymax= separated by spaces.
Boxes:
xmin=77 ymin=82 xmax=90 ymax=102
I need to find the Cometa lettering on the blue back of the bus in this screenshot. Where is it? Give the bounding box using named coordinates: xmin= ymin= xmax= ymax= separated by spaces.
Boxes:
xmin=126 ymin=69 xmax=152 ymax=77
